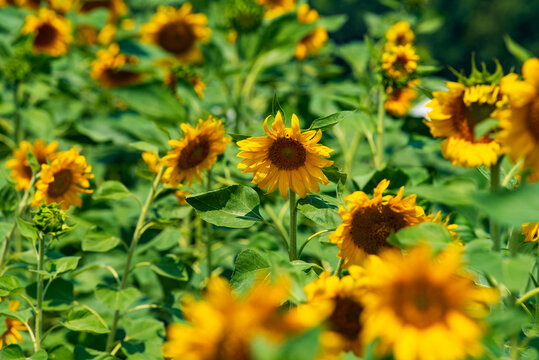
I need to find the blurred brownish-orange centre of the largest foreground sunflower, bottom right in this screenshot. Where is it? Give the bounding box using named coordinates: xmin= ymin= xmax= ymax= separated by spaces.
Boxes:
xmin=390 ymin=278 xmax=455 ymax=328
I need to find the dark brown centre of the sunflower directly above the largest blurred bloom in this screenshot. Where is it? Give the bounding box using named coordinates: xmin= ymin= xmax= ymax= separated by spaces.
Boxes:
xmin=350 ymin=204 xmax=408 ymax=254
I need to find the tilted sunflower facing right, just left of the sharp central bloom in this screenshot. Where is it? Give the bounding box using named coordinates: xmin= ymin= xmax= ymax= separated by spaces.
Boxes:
xmin=161 ymin=115 xmax=231 ymax=186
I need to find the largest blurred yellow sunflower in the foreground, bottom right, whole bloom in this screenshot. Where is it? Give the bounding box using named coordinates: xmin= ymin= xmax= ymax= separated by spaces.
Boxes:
xmin=362 ymin=245 xmax=498 ymax=360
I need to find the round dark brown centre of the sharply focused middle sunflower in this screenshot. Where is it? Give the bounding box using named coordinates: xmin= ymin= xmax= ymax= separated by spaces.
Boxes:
xmin=268 ymin=138 xmax=307 ymax=170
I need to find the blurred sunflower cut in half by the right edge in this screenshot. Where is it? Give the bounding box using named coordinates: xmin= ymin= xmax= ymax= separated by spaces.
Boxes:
xmin=498 ymin=58 xmax=539 ymax=177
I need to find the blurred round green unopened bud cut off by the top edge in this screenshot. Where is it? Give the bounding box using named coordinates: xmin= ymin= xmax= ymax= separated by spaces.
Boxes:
xmin=225 ymin=0 xmax=264 ymax=33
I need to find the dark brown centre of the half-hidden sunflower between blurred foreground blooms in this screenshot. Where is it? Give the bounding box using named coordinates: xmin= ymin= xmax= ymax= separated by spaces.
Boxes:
xmin=329 ymin=297 xmax=363 ymax=340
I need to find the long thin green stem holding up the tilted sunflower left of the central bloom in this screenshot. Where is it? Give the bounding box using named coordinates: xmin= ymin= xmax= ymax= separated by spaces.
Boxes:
xmin=105 ymin=166 xmax=165 ymax=352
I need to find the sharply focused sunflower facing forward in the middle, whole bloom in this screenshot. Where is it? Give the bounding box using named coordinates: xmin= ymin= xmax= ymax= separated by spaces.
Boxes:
xmin=238 ymin=112 xmax=333 ymax=198
